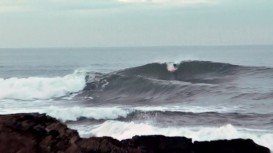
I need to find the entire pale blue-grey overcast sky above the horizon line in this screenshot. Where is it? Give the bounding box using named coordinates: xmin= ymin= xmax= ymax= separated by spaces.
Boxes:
xmin=0 ymin=0 xmax=273 ymax=48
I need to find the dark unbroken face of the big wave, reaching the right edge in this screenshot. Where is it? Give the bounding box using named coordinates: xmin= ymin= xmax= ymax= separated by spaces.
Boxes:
xmin=78 ymin=61 xmax=273 ymax=104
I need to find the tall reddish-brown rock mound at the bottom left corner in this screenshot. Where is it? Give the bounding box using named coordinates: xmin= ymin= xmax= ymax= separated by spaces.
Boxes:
xmin=0 ymin=113 xmax=80 ymax=153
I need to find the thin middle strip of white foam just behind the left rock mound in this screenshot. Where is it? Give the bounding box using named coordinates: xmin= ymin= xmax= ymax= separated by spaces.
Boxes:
xmin=0 ymin=104 xmax=239 ymax=122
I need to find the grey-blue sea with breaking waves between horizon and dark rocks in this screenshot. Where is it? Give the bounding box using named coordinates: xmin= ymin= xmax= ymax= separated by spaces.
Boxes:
xmin=0 ymin=46 xmax=273 ymax=150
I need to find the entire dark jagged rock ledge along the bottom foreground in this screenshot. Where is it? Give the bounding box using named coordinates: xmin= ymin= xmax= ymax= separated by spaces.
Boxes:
xmin=0 ymin=114 xmax=270 ymax=153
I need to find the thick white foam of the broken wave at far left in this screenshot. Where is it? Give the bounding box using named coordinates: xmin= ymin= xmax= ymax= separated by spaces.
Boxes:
xmin=0 ymin=71 xmax=85 ymax=100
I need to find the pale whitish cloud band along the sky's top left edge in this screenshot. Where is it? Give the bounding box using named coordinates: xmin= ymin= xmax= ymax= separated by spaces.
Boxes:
xmin=0 ymin=0 xmax=212 ymax=13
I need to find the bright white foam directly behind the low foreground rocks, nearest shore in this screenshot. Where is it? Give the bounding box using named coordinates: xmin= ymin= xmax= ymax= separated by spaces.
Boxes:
xmin=78 ymin=121 xmax=273 ymax=150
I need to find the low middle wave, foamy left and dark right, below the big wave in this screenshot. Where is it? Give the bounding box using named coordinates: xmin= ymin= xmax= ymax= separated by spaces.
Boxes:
xmin=3 ymin=106 xmax=273 ymax=129
